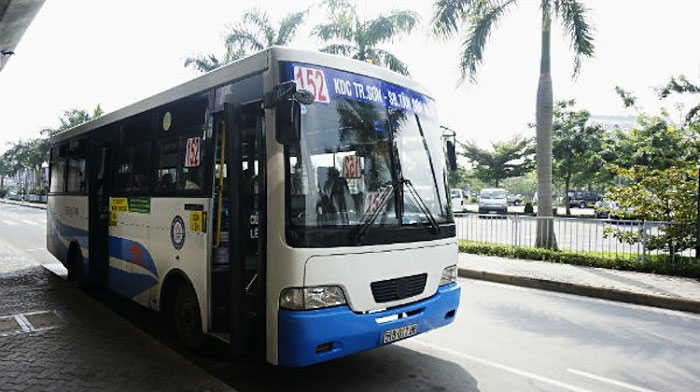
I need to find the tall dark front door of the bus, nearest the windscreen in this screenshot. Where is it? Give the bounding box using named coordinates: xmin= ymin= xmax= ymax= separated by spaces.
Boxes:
xmin=224 ymin=102 xmax=266 ymax=356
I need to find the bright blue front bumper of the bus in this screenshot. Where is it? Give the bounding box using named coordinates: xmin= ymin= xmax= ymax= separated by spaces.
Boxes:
xmin=278 ymin=283 xmax=460 ymax=367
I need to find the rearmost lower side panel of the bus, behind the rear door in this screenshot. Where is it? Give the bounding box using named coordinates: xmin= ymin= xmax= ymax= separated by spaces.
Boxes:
xmin=46 ymin=195 xmax=89 ymax=267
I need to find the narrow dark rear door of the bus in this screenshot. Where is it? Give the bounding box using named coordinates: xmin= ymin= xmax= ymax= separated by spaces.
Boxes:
xmin=88 ymin=141 xmax=110 ymax=288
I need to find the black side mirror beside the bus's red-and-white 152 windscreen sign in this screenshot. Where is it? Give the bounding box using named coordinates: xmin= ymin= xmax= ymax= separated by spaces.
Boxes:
xmin=266 ymin=81 xmax=314 ymax=145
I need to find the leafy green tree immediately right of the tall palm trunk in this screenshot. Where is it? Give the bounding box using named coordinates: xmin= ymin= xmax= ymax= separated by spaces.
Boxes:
xmin=552 ymin=99 xmax=604 ymax=215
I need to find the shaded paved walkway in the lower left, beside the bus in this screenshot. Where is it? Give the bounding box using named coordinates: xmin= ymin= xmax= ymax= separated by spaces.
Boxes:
xmin=0 ymin=270 xmax=231 ymax=391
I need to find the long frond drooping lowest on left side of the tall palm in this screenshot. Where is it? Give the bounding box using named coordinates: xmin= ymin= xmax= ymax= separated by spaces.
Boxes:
xmin=460 ymin=0 xmax=516 ymax=82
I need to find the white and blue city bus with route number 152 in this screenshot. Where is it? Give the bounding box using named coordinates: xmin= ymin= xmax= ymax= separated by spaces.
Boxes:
xmin=47 ymin=47 xmax=460 ymax=367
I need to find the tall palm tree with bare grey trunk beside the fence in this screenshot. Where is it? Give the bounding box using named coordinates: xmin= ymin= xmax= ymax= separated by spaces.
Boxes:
xmin=433 ymin=0 xmax=594 ymax=248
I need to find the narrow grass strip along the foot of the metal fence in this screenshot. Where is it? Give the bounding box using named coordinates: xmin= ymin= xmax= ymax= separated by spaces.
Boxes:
xmin=459 ymin=240 xmax=700 ymax=279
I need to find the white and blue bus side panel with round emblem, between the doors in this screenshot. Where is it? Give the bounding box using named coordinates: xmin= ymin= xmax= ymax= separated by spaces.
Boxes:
xmin=109 ymin=197 xmax=210 ymax=331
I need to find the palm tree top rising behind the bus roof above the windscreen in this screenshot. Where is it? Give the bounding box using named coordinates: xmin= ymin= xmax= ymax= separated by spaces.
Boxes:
xmin=311 ymin=0 xmax=419 ymax=75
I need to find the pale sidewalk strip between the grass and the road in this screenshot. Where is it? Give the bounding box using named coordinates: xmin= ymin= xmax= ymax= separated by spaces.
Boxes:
xmin=459 ymin=253 xmax=700 ymax=313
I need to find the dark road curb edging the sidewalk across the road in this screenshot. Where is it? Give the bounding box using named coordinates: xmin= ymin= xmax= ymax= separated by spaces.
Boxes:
xmin=459 ymin=268 xmax=700 ymax=314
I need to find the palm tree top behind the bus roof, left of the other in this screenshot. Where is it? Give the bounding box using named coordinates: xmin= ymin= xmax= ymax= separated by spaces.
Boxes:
xmin=185 ymin=9 xmax=307 ymax=72
